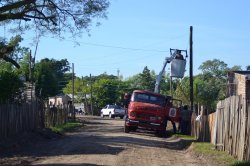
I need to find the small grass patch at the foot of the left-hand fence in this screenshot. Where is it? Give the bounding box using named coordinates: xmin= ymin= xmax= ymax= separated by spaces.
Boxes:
xmin=51 ymin=121 xmax=83 ymax=134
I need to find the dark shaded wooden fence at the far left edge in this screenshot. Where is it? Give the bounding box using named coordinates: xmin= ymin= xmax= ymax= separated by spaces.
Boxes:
xmin=0 ymin=101 xmax=44 ymax=140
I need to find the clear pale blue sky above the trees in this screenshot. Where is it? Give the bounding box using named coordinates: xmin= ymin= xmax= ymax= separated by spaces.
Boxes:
xmin=3 ymin=0 xmax=250 ymax=79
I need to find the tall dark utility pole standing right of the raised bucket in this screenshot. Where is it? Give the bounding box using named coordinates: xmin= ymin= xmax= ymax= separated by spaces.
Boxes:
xmin=189 ymin=26 xmax=194 ymax=111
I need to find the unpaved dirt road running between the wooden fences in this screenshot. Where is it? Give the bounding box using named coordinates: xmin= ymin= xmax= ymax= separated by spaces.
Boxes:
xmin=0 ymin=116 xmax=211 ymax=166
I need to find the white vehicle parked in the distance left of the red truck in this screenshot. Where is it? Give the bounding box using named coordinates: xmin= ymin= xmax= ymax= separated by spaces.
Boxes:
xmin=100 ymin=105 xmax=126 ymax=119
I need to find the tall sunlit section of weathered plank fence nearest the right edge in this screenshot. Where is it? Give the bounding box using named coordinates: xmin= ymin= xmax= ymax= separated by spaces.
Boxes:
xmin=212 ymin=96 xmax=250 ymax=161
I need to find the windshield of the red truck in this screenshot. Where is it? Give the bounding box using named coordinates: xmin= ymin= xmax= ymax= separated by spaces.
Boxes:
xmin=131 ymin=93 xmax=166 ymax=107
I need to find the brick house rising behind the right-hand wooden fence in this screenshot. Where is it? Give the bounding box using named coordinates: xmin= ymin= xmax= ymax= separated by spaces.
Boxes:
xmin=227 ymin=71 xmax=250 ymax=100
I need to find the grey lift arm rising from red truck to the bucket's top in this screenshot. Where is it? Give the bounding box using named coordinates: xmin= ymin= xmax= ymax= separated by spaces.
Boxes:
xmin=154 ymin=48 xmax=187 ymax=93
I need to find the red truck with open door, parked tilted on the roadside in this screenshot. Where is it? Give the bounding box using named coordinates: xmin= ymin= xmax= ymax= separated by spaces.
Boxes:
xmin=124 ymin=90 xmax=179 ymax=136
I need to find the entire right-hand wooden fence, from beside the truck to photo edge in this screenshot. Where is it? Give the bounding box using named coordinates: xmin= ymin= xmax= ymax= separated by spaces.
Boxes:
xmin=192 ymin=96 xmax=250 ymax=161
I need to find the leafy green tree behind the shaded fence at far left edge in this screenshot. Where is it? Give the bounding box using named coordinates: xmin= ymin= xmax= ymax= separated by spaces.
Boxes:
xmin=0 ymin=36 xmax=27 ymax=102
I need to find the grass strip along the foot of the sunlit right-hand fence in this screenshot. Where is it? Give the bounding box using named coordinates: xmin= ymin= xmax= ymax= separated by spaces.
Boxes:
xmin=175 ymin=134 xmax=250 ymax=166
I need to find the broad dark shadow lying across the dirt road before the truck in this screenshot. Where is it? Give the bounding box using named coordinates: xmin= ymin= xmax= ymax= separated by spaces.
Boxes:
xmin=0 ymin=131 xmax=191 ymax=157
